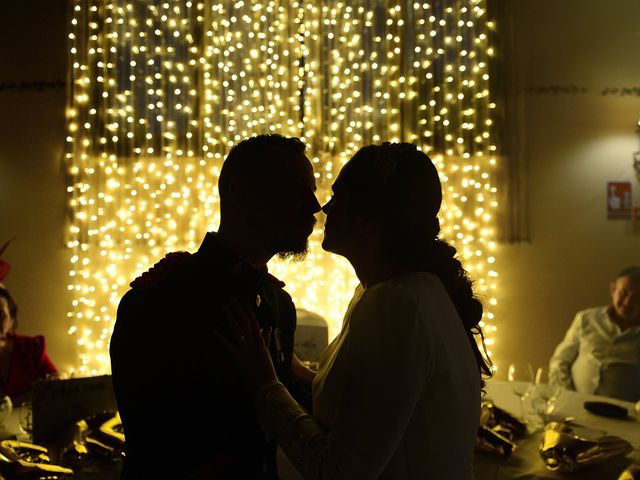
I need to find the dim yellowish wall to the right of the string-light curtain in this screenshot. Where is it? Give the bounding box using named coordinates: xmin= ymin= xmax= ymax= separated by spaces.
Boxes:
xmin=494 ymin=0 xmax=640 ymax=372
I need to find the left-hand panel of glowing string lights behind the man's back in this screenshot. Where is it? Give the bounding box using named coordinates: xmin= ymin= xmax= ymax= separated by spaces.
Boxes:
xmin=67 ymin=1 xmax=211 ymax=374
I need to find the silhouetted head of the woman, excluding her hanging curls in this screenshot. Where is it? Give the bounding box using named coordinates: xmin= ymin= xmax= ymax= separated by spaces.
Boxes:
xmin=323 ymin=142 xmax=442 ymax=260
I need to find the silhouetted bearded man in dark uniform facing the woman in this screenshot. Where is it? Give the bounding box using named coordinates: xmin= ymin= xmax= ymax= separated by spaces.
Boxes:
xmin=110 ymin=134 xmax=320 ymax=479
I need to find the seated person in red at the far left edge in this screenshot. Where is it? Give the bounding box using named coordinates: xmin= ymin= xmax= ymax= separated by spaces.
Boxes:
xmin=0 ymin=284 xmax=58 ymax=404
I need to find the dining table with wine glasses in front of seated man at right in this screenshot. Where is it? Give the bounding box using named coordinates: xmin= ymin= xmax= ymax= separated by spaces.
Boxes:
xmin=474 ymin=380 xmax=640 ymax=480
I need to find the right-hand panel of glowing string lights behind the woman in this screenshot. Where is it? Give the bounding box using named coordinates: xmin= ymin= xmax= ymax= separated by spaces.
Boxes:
xmin=305 ymin=0 xmax=497 ymax=366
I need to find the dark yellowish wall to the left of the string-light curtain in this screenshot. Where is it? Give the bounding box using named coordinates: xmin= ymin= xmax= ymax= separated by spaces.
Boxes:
xmin=0 ymin=0 xmax=75 ymax=368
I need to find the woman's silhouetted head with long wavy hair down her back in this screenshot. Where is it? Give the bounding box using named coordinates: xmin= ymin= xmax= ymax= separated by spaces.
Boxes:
xmin=322 ymin=142 xmax=492 ymax=386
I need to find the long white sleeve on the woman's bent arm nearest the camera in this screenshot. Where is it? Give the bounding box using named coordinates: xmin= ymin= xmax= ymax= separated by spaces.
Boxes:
xmin=252 ymin=288 xmax=432 ymax=480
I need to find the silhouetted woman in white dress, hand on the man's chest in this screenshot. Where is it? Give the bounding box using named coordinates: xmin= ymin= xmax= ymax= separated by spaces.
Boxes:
xmin=220 ymin=143 xmax=491 ymax=480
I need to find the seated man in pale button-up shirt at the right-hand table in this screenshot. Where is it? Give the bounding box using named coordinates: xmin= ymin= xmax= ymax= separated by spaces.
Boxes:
xmin=549 ymin=266 xmax=640 ymax=402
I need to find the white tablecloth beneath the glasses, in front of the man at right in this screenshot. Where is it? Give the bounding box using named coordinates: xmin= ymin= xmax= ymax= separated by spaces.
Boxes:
xmin=475 ymin=381 xmax=640 ymax=480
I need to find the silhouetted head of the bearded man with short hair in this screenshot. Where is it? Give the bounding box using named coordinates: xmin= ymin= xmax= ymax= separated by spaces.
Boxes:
xmin=218 ymin=134 xmax=320 ymax=256
